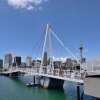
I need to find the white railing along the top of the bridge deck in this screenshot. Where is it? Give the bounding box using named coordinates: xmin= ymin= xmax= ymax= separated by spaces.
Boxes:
xmin=18 ymin=67 xmax=86 ymax=79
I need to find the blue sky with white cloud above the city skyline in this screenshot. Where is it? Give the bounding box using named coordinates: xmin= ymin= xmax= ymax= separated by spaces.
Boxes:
xmin=0 ymin=0 xmax=100 ymax=59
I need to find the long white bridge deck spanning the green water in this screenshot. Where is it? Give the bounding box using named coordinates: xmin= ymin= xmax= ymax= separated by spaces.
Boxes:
xmin=3 ymin=68 xmax=83 ymax=83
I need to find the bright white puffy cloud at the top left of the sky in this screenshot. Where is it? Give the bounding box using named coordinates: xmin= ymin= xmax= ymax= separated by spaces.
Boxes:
xmin=8 ymin=0 xmax=48 ymax=10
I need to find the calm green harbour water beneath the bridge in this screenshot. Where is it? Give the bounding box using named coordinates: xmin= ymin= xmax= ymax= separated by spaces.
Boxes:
xmin=0 ymin=76 xmax=95 ymax=100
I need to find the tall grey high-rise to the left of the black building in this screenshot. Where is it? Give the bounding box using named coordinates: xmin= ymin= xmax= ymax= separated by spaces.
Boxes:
xmin=4 ymin=53 xmax=12 ymax=68
